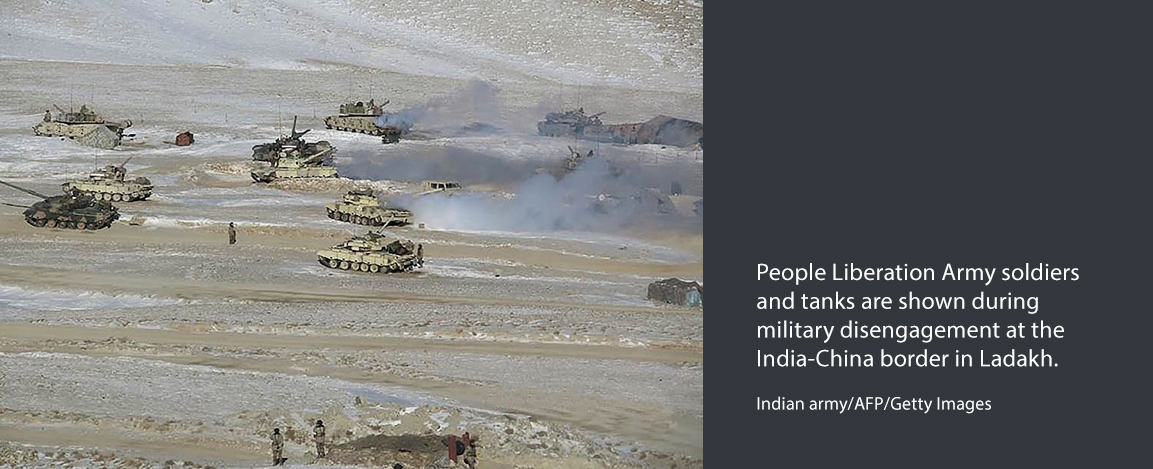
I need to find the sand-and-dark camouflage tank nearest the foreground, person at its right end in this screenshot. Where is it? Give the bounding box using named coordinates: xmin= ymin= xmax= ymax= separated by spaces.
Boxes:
xmin=316 ymin=232 xmax=424 ymax=273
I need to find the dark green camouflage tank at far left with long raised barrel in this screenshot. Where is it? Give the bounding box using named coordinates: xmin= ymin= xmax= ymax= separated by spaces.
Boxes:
xmin=0 ymin=181 xmax=120 ymax=229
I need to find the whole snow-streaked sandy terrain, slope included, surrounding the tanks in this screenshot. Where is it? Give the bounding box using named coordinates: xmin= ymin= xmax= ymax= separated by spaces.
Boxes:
xmin=0 ymin=0 xmax=703 ymax=468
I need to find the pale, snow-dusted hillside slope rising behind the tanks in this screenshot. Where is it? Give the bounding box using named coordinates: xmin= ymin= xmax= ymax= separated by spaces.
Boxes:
xmin=0 ymin=0 xmax=703 ymax=89
